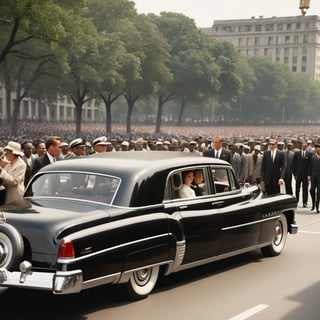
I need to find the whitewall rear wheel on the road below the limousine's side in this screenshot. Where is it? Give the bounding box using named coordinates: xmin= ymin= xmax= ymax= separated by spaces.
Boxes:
xmin=125 ymin=266 xmax=160 ymax=300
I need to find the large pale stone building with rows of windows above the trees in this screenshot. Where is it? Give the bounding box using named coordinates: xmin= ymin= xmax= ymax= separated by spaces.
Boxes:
xmin=203 ymin=16 xmax=320 ymax=80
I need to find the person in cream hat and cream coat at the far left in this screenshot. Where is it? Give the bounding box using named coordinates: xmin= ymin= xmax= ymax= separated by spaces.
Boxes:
xmin=0 ymin=141 xmax=26 ymax=204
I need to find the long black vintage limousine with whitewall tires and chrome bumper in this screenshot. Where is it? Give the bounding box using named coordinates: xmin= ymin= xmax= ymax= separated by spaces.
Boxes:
xmin=0 ymin=151 xmax=298 ymax=299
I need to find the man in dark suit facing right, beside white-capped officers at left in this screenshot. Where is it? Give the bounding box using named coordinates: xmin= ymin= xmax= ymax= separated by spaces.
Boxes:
xmin=31 ymin=136 xmax=61 ymax=176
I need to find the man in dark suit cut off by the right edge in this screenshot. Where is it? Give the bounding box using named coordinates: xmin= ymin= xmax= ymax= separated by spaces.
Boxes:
xmin=308 ymin=144 xmax=320 ymax=213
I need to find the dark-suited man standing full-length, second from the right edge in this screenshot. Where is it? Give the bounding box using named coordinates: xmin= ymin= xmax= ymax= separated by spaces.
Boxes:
xmin=292 ymin=142 xmax=312 ymax=208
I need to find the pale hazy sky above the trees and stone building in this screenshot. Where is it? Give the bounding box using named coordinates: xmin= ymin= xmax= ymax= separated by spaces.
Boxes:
xmin=132 ymin=0 xmax=320 ymax=28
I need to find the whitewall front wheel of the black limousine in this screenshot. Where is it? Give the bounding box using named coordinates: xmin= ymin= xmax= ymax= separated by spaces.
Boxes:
xmin=261 ymin=214 xmax=288 ymax=257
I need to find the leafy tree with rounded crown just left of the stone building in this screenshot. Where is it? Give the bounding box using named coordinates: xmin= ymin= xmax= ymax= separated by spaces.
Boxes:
xmin=149 ymin=12 xmax=219 ymax=127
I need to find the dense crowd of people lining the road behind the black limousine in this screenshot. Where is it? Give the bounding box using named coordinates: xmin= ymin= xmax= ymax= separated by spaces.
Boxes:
xmin=0 ymin=124 xmax=320 ymax=212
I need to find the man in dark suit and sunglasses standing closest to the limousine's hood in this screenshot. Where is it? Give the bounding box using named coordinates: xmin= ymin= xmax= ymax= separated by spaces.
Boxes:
xmin=261 ymin=139 xmax=286 ymax=195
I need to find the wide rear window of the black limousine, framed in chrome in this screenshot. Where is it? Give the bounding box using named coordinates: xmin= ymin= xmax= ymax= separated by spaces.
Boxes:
xmin=25 ymin=172 xmax=120 ymax=204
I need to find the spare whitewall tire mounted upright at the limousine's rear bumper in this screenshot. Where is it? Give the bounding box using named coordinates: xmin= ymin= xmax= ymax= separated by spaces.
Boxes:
xmin=0 ymin=223 xmax=24 ymax=270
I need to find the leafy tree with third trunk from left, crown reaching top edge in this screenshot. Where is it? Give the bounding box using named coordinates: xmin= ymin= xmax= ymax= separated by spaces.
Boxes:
xmin=89 ymin=0 xmax=140 ymax=133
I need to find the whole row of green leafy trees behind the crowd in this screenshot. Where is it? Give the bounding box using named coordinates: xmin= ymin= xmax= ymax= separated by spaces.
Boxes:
xmin=0 ymin=0 xmax=320 ymax=135
